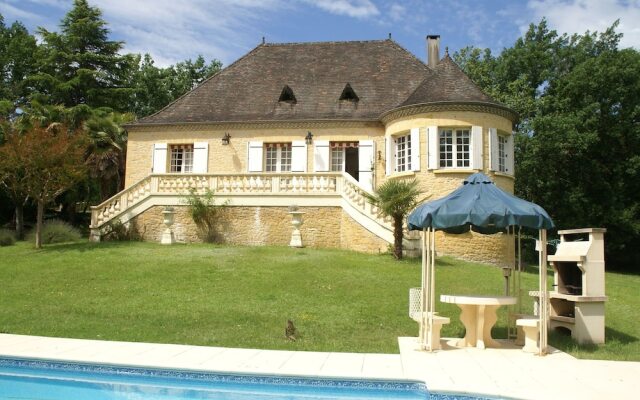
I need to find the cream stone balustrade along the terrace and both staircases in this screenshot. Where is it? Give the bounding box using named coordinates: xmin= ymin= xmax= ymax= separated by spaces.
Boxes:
xmin=90 ymin=173 xmax=420 ymax=256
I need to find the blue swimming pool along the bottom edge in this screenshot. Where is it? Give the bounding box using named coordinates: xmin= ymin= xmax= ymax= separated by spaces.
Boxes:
xmin=0 ymin=358 xmax=490 ymax=400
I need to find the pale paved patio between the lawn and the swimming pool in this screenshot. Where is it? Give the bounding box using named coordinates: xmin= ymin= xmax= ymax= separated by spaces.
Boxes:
xmin=0 ymin=334 xmax=640 ymax=400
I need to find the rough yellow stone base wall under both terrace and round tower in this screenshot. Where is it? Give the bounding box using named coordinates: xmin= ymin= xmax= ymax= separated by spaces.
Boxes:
xmin=133 ymin=206 xmax=514 ymax=265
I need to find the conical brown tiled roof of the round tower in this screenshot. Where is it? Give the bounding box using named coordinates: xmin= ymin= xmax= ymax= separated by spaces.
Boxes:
xmin=402 ymin=54 xmax=499 ymax=106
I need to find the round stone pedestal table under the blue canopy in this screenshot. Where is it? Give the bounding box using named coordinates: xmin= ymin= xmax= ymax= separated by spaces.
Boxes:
xmin=440 ymin=294 xmax=518 ymax=349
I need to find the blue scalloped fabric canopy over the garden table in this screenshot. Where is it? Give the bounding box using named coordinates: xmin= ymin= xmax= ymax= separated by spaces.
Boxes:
xmin=407 ymin=172 xmax=554 ymax=234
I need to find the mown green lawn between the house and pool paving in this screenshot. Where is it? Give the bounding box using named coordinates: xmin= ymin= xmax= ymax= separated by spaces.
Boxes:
xmin=0 ymin=242 xmax=640 ymax=360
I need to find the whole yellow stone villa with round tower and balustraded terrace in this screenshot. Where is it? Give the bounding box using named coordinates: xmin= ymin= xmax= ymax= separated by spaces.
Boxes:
xmin=91 ymin=36 xmax=517 ymax=264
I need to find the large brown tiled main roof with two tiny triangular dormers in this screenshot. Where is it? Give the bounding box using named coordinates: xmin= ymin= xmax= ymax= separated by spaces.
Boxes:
xmin=138 ymin=40 xmax=430 ymax=124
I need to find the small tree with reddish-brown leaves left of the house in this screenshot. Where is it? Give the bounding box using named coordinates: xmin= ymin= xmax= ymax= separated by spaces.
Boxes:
xmin=2 ymin=124 xmax=86 ymax=248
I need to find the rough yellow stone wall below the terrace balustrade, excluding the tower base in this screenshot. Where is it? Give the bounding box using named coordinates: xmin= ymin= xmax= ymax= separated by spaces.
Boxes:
xmin=133 ymin=206 xmax=388 ymax=253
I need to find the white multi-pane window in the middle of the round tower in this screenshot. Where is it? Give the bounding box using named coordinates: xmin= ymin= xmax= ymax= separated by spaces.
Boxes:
xmin=438 ymin=127 xmax=473 ymax=169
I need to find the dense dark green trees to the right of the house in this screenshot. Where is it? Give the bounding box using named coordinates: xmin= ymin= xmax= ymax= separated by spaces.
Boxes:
xmin=455 ymin=19 xmax=640 ymax=268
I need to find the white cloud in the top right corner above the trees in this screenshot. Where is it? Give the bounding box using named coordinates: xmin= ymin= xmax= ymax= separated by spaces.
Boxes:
xmin=521 ymin=0 xmax=640 ymax=48
